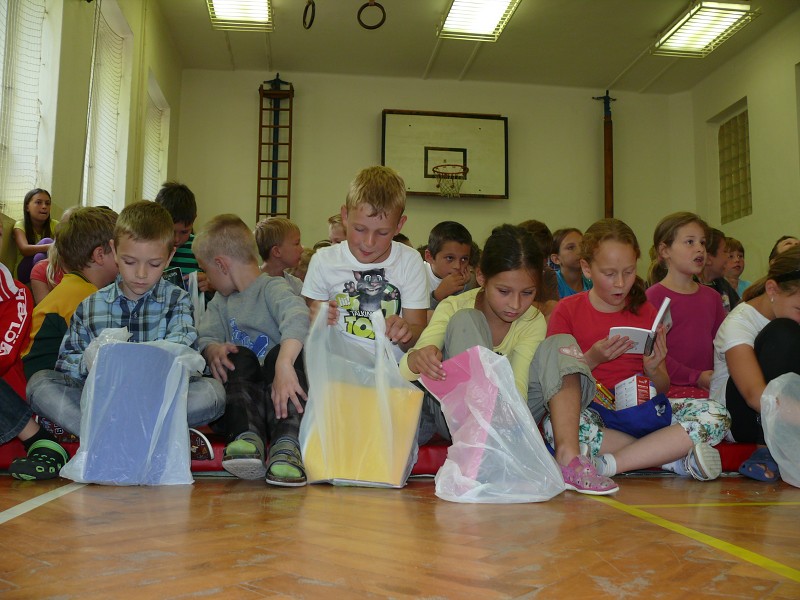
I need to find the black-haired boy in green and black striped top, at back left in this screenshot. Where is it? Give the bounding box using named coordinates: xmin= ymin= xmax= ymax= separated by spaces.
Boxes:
xmin=155 ymin=181 xmax=211 ymax=292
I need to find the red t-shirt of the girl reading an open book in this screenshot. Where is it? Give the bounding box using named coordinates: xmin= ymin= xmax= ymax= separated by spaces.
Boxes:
xmin=547 ymin=292 xmax=658 ymax=392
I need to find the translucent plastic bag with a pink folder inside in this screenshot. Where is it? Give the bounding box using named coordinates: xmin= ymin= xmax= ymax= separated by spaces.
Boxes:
xmin=423 ymin=346 xmax=565 ymax=504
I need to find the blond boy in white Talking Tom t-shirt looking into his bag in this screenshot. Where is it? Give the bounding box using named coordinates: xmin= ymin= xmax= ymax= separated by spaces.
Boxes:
xmin=303 ymin=167 xmax=430 ymax=361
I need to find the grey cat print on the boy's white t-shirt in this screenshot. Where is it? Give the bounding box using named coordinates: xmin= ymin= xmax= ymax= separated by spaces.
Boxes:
xmin=336 ymin=269 xmax=402 ymax=340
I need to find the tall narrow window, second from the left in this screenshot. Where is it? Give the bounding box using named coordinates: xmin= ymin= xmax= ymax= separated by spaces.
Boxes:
xmin=81 ymin=0 xmax=133 ymax=211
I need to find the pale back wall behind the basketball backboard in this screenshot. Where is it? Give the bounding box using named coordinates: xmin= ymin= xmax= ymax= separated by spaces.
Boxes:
xmin=178 ymin=70 xmax=694 ymax=258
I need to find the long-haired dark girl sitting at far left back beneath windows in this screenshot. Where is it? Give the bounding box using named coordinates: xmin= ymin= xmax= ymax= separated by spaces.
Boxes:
xmin=14 ymin=188 xmax=58 ymax=284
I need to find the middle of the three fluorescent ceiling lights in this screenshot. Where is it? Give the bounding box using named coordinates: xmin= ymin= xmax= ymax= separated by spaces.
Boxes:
xmin=437 ymin=0 xmax=520 ymax=42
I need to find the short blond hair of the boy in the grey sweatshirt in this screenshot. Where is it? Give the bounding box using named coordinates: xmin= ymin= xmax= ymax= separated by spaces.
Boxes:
xmin=192 ymin=214 xmax=258 ymax=265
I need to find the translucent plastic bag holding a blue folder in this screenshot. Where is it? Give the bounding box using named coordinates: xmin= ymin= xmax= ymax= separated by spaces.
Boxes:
xmin=61 ymin=336 xmax=205 ymax=485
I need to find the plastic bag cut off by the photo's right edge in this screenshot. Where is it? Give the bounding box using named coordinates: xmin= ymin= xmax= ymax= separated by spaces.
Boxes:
xmin=761 ymin=373 xmax=800 ymax=487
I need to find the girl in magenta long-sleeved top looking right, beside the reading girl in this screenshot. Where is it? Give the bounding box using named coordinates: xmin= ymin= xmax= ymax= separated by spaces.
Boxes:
xmin=646 ymin=212 xmax=725 ymax=398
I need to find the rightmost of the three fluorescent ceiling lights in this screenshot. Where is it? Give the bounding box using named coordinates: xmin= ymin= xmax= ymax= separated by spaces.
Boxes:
xmin=652 ymin=1 xmax=759 ymax=58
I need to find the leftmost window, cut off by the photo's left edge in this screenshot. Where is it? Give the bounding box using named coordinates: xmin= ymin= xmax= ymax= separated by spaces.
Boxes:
xmin=0 ymin=0 xmax=49 ymax=219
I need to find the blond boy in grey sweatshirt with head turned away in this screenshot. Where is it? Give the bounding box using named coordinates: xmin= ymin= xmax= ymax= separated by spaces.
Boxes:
xmin=192 ymin=215 xmax=309 ymax=486
